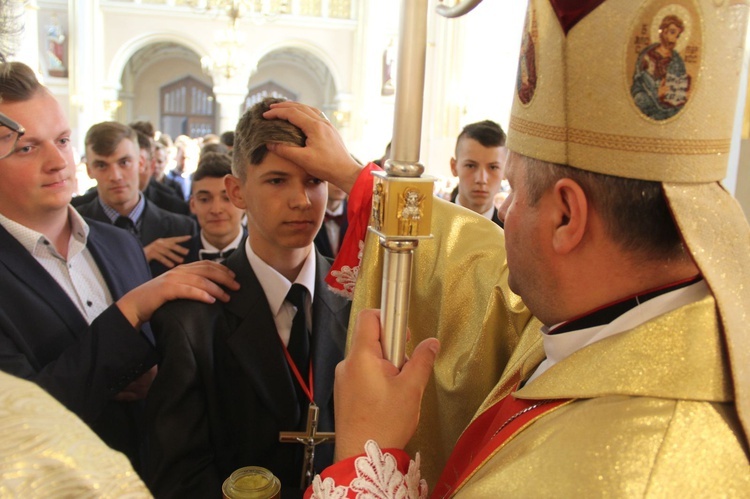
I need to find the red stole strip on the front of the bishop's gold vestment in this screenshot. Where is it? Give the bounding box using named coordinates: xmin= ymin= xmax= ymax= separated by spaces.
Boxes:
xmin=431 ymin=386 xmax=570 ymax=497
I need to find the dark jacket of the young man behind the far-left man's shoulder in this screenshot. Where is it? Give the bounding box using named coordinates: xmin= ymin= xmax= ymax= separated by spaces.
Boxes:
xmin=76 ymin=198 xmax=198 ymax=277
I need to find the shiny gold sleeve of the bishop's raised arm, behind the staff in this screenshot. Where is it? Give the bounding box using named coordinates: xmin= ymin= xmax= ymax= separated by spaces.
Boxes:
xmin=350 ymin=197 xmax=541 ymax=485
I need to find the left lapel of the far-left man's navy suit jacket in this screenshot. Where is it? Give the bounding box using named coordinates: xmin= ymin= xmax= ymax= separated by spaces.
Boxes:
xmin=0 ymin=226 xmax=87 ymax=336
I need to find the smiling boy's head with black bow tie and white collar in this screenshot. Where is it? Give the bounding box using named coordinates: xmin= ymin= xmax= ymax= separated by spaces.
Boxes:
xmin=185 ymin=152 xmax=246 ymax=263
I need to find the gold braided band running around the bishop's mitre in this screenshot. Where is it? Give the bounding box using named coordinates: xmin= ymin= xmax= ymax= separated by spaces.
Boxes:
xmin=510 ymin=116 xmax=731 ymax=155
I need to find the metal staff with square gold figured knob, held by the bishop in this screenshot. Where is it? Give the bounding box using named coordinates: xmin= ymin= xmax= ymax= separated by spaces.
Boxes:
xmin=370 ymin=0 xmax=434 ymax=368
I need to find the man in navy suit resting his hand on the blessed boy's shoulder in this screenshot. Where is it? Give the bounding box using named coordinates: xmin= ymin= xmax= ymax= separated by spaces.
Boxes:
xmin=0 ymin=62 xmax=236 ymax=469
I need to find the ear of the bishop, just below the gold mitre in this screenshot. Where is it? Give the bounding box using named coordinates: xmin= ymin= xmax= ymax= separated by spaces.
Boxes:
xmin=552 ymin=178 xmax=589 ymax=254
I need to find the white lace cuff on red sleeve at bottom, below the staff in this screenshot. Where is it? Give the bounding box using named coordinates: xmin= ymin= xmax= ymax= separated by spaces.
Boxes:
xmin=311 ymin=440 xmax=427 ymax=499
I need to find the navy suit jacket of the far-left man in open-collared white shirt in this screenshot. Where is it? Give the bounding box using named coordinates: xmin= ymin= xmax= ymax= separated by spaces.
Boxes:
xmin=0 ymin=220 xmax=156 ymax=469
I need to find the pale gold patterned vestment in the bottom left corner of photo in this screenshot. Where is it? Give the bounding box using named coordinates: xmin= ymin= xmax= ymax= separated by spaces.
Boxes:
xmin=0 ymin=372 xmax=151 ymax=499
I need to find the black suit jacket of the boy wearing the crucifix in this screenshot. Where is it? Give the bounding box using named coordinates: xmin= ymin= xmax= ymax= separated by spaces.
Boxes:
xmin=146 ymin=244 xmax=350 ymax=498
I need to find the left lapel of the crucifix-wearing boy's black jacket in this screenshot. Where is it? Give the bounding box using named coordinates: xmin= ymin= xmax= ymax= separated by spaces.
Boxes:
xmin=220 ymin=248 xmax=299 ymax=428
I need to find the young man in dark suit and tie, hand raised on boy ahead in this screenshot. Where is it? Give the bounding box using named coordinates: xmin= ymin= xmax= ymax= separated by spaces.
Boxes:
xmin=76 ymin=121 xmax=198 ymax=277
